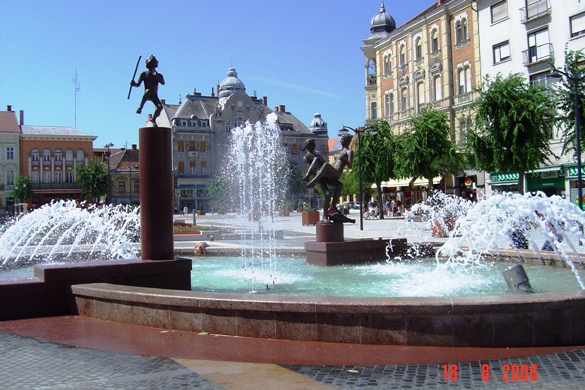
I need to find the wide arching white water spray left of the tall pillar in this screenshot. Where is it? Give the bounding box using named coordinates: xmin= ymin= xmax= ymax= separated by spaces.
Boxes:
xmin=0 ymin=200 xmax=140 ymax=267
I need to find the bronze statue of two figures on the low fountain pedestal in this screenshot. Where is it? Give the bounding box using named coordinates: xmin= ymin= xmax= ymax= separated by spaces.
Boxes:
xmin=301 ymin=134 xmax=355 ymax=223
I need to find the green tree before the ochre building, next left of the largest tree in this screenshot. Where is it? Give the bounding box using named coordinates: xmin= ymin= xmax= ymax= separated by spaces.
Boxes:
xmin=394 ymin=107 xmax=463 ymax=194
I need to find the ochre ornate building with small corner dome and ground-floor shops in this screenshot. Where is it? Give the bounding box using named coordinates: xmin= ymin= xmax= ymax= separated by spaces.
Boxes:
xmin=361 ymin=0 xmax=485 ymax=207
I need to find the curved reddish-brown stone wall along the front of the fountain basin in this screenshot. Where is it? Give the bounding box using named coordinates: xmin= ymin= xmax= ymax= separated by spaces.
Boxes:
xmin=70 ymin=283 xmax=585 ymax=347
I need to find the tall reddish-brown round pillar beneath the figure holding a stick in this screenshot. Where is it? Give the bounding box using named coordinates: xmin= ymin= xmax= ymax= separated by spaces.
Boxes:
xmin=139 ymin=127 xmax=174 ymax=260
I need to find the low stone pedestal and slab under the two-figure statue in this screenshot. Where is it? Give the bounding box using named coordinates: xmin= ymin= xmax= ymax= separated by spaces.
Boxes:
xmin=305 ymin=223 xmax=408 ymax=266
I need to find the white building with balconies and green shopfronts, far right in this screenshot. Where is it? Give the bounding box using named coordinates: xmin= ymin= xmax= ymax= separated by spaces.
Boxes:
xmin=477 ymin=0 xmax=585 ymax=201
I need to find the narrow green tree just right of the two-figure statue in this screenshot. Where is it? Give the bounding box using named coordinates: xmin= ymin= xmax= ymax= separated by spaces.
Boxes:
xmin=352 ymin=120 xmax=397 ymax=219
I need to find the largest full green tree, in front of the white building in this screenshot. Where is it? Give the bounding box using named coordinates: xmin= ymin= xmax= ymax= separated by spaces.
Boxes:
xmin=467 ymin=73 xmax=555 ymax=193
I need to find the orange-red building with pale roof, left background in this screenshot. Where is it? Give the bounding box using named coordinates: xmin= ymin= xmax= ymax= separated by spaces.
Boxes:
xmin=20 ymin=123 xmax=97 ymax=207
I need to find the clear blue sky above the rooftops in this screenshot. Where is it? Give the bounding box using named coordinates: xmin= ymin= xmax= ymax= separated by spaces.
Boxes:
xmin=0 ymin=0 xmax=428 ymax=148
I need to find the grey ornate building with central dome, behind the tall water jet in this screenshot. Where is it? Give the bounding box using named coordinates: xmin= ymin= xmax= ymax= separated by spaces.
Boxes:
xmin=158 ymin=67 xmax=328 ymax=211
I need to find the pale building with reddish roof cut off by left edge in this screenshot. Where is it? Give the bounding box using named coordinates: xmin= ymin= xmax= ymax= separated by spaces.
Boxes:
xmin=0 ymin=106 xmax=22 ymax=211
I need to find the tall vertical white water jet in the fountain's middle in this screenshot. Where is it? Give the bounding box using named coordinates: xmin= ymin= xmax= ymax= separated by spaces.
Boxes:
xmin=224 ymin=114 xmax=287 ymax=292
